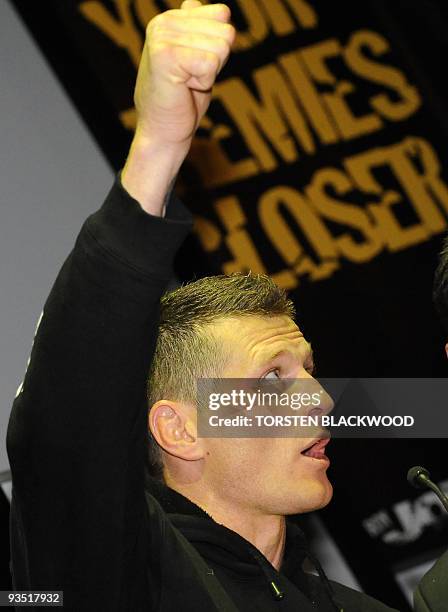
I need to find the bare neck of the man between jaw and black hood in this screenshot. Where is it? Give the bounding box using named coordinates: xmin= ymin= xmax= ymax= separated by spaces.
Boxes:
xmin=167 ymin=482 xmax=286 ymax=569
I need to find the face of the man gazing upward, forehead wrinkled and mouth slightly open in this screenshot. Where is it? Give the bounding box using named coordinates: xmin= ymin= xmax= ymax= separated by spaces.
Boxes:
xmin=203 ymin=316 xmax=332 ymax=515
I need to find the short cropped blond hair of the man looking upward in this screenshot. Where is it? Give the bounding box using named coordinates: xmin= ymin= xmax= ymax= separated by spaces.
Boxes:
xmin=147 ymin=273 xmax=295 ymax=479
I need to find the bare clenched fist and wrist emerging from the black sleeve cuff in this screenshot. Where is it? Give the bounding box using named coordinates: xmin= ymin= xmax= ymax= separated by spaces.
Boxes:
xmin=121 ymin=0 xmax=235 ymax=215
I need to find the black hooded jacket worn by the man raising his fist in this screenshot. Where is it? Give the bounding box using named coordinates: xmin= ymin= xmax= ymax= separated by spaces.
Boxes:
xmin=7 ymin=179 xmax=398 ymax=612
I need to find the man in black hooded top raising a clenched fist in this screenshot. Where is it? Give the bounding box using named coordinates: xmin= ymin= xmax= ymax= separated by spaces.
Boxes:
xmin=8 ymin=0 xmax=396 ymax=612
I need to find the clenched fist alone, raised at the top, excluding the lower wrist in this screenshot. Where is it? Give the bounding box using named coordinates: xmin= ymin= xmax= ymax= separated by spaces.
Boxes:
xmin=135 ymin=0 xmax=235 ymax=146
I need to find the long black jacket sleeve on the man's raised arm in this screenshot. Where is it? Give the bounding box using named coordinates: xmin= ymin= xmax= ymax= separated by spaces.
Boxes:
xmin=7 ymin=179 xmax=191 ymax=612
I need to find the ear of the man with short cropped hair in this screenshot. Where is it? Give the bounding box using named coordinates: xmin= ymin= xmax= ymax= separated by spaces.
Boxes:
xmin=148 ymin=400 xmax=203 ymax=461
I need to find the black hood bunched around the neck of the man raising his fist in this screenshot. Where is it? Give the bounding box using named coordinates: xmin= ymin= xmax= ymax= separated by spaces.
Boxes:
xmin=147 ymin=477 xmax=341 ymax=612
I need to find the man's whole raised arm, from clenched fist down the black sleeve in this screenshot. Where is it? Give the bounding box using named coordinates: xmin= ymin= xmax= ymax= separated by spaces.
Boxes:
xmin=7 ymin=1 xmax=233 ymax=612
